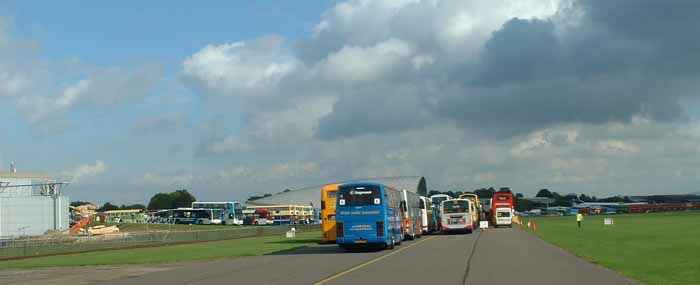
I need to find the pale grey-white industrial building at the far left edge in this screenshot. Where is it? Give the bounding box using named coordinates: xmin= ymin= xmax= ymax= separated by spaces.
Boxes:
xmin=0 ymin=166 xmax=70 ymax=238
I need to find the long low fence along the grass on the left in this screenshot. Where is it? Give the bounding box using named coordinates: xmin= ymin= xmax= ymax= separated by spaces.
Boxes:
xmin=0 ymin=225 xmax=321 ymax=259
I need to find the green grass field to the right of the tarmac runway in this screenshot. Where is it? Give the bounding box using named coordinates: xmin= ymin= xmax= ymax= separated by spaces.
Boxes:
xmin=524 ymin=212 xmax=700 ymax=284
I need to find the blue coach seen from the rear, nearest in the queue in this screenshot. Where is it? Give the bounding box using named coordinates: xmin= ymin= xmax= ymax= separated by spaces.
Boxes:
xmin=336 ymin=182 xmax=403 ymax=249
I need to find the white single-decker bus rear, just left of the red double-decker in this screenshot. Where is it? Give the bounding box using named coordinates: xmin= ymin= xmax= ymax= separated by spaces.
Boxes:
xmin=440 ymin=199 xmax=474 ymax=233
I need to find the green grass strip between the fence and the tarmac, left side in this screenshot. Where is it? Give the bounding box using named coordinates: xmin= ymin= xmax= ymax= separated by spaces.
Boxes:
xmin=0 ymin=232 xmax=321 ymax=269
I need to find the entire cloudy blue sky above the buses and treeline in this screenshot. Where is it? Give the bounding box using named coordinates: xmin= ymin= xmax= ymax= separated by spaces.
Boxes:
xmin=0 ymin=0 xmax=700 ymax=203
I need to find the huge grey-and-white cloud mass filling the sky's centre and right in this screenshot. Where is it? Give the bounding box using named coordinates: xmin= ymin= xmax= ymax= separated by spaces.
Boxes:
xmin=174 ymin=0 xmax=700 ymax=197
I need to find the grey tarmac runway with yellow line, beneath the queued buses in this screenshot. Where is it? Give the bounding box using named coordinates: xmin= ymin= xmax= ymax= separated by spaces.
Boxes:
xmin=0 ymin=228 xmax=635 ymax=285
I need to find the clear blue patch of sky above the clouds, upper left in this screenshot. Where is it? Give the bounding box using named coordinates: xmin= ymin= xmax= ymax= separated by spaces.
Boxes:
xmin=6 ymin=1 xmax=333 ymax=65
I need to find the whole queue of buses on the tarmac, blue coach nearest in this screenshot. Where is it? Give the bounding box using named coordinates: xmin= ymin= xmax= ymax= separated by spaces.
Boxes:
xmin=321 ymin=182 xmax=514 ymax=249
